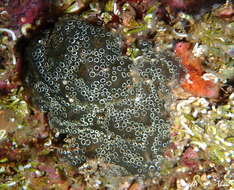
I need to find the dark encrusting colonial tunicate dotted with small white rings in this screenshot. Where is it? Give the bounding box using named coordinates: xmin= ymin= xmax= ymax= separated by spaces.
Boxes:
xmin=26 ymin=16 xmax=181 ymax=176
